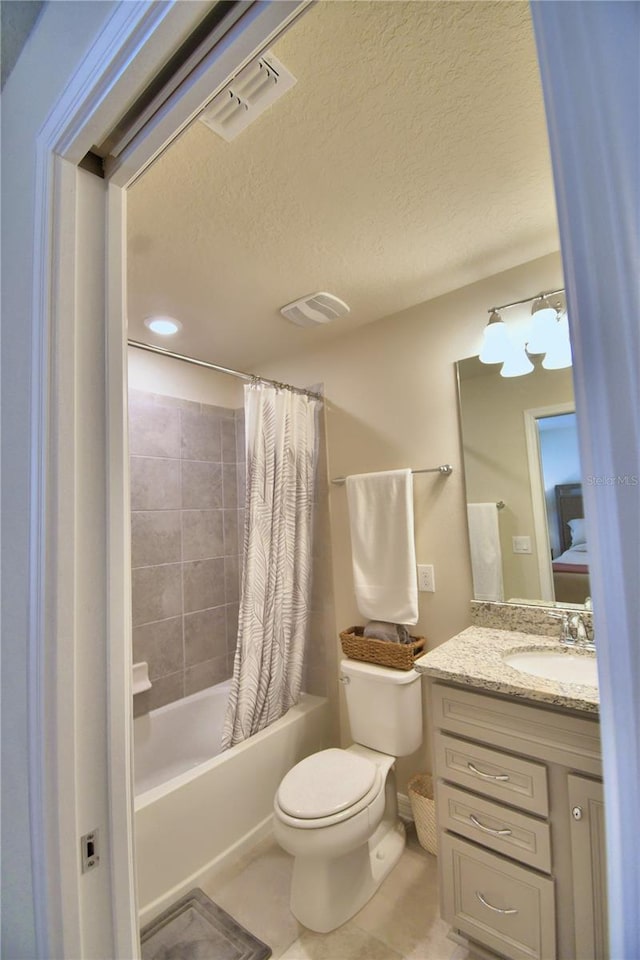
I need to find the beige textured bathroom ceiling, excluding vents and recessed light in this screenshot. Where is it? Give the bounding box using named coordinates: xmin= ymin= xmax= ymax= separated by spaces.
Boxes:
xmin=128 ymin=0 xmax=559 ymax=369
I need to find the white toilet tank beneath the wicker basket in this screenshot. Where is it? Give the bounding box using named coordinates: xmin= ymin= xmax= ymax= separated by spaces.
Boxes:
xmin=340 ymin=660 xmax=422 ymax=757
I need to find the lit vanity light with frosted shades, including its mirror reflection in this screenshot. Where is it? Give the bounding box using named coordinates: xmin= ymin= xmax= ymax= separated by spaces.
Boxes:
xmin=479 ymin=289 xmax=571 ymax=377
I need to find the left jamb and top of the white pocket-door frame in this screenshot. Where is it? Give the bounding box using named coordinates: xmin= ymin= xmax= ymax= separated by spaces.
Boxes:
xmin=28 ymin=0 xmax=311 ymax=958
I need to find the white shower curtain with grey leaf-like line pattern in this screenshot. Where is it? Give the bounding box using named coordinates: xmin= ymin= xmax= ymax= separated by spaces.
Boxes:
xmin=222 ymin=383 xmax=321 ymax=750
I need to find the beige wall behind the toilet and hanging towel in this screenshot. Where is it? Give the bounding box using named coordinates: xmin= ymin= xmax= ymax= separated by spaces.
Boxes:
xmin=258 ymin=248 xmax=562 ymax=792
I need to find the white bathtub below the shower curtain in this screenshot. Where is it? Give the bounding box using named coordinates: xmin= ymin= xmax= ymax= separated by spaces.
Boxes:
xmin=134 ymin=681 xmax=330 ymax=925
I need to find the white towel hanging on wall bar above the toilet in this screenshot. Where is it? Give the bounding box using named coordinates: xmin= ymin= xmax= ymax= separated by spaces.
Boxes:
xmin=347 ymin=470 xmax=418 ymax=624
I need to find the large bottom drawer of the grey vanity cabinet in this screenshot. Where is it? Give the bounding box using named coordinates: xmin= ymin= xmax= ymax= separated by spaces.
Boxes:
xmin=439 ymin=833 xmax=556 ymax=960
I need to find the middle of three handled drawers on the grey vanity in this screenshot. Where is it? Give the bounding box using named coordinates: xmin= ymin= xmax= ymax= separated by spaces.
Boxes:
xmin=436 ymin=780 xmax=551 ymax=873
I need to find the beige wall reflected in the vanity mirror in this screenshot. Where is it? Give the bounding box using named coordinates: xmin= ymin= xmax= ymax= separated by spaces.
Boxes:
xmin=461 ymin=367 xmax=573 ymax=600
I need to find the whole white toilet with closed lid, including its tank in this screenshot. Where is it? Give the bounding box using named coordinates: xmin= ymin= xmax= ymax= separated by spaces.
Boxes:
xmin=274 ymin=660 xmax=422 ymax=933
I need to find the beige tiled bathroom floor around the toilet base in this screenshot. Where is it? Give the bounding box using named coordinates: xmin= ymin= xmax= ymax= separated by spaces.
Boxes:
xmin=203 ymin=828 xmax=468 ymax=960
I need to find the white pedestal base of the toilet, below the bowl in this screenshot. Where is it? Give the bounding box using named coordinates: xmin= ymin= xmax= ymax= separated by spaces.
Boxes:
xmin=291 ymin=817 xmax=405 ymax=933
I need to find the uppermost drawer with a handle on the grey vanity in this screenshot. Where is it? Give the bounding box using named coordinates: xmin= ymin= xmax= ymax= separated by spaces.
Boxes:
xmin=435 ymin=731 xmax=549 ymax=817
